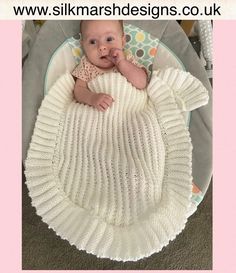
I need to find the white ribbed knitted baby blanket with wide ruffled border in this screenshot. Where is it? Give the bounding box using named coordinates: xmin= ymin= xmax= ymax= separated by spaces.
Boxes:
xmin=25 ymin=68 xmax=208 ymax=261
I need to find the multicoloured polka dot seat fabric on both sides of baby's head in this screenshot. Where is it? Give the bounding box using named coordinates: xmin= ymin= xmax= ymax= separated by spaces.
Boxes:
xmin=68 ymin=24 xmax=159 ymax=77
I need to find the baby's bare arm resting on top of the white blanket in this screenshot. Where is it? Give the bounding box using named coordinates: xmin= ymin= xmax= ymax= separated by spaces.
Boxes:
xmin=74 ymin=79 xmax=113 ymax=112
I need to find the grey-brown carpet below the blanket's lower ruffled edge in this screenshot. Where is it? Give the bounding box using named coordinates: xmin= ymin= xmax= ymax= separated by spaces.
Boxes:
xmin=22 ymin=168 xmax=212 ymax=270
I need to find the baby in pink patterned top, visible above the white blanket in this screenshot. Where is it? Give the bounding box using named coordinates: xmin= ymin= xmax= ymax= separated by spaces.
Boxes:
xmin=72 ymin=20 xmax=147 ymax=111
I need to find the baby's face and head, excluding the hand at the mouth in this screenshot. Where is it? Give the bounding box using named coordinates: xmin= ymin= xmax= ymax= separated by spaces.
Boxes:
xmin=82 ymin=20 xmax=125 ymax=69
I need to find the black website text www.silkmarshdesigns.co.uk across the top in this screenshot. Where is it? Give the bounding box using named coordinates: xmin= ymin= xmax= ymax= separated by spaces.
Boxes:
xmin=13 ymin=3 xmax=221 ymax=19
